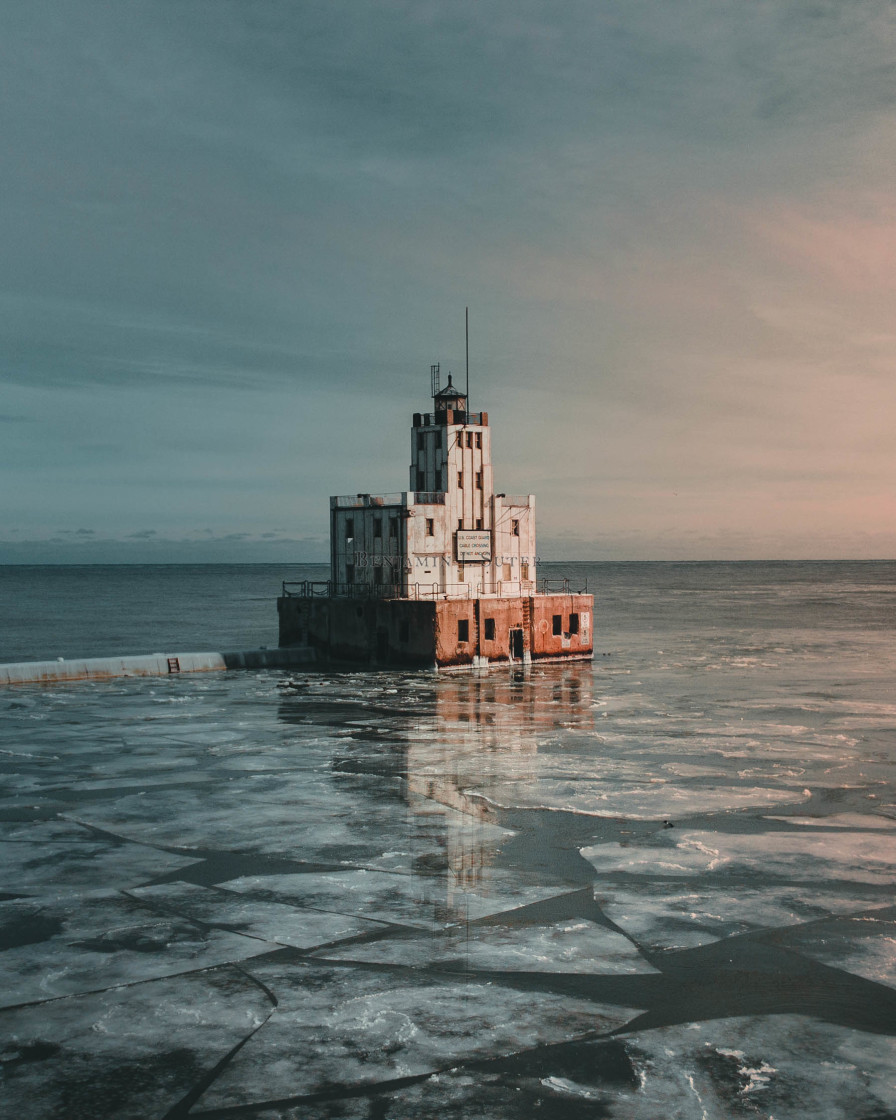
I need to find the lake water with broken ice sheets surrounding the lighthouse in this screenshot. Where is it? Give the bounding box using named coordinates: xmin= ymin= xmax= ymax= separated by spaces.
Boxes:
xmin=0 ymin=562 xmax=896 ymax=1120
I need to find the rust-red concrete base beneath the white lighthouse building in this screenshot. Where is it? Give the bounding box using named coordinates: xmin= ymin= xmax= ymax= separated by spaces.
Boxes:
xmin=277 ymin=595 xmax=594 ymax=669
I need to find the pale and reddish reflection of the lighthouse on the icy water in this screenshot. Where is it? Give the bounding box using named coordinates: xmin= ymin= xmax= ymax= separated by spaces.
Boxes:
xmin=405 ymin=664 xmax=592 ymax=920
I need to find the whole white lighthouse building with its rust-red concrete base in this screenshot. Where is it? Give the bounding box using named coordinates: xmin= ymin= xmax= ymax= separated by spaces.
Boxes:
xmin=278 ymin=365 xmax=594 ymax=669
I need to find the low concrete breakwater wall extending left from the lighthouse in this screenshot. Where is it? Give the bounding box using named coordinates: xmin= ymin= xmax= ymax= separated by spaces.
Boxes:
xmin=0 ymin=646 xmax=315 ymax=685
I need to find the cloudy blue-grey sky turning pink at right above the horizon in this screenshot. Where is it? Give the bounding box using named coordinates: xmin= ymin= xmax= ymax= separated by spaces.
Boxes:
xmin=0 ymin=0 xmax=896 ymax=563
